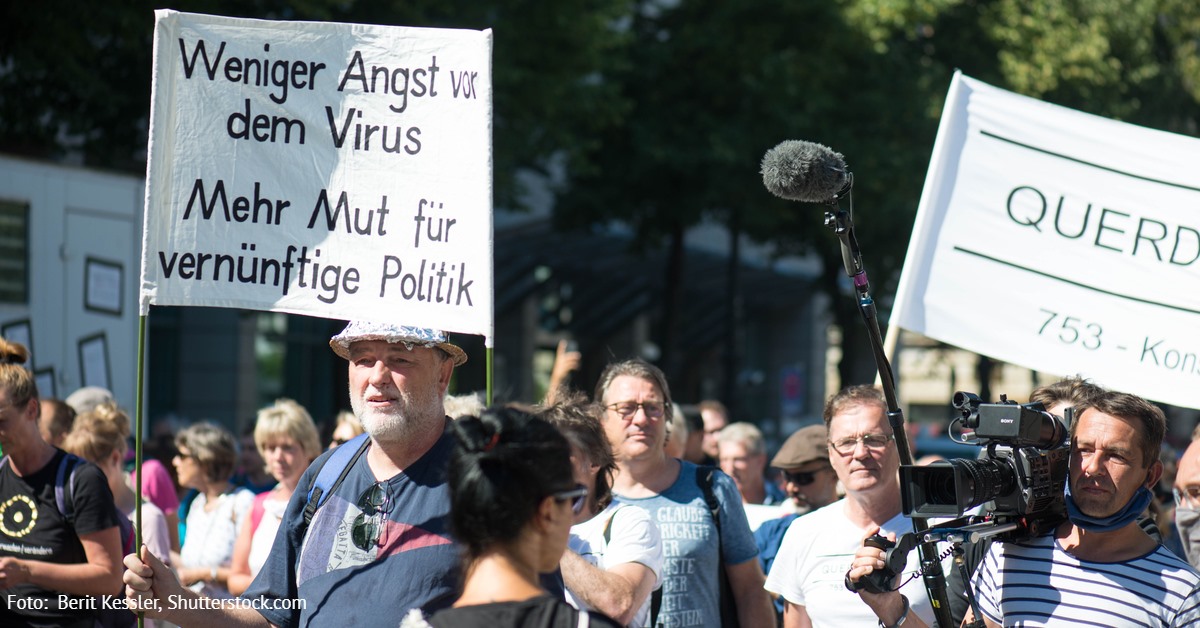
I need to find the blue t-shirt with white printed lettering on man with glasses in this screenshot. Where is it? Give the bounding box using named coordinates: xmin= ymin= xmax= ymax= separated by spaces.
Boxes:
xmin=616 ymin=460 xmax=758 ymax=628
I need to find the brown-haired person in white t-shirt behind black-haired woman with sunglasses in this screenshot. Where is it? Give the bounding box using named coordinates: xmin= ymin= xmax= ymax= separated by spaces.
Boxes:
xmin=538 ymin=394 xmax=662 ymax=628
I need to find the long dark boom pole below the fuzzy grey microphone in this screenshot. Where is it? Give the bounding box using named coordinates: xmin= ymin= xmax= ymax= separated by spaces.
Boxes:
xmin=824 ymin=180 xmax=950 ymax=627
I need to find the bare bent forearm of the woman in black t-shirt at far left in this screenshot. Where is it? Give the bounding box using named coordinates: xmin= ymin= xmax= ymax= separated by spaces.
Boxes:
xmin=0 ymin=526 xmax=121 ymax=596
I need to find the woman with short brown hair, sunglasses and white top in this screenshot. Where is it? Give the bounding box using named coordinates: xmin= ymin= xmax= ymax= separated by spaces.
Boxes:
xmin=172 ymin=423 xmax=254 ymax=598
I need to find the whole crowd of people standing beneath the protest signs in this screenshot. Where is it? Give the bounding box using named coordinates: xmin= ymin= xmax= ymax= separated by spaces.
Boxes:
xmin=0 ymin=322 xmax=1200 ymax=628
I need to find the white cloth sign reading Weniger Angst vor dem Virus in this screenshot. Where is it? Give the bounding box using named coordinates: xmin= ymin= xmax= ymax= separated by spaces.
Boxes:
xmin=140 ymin=11 xmax=493 ymax=346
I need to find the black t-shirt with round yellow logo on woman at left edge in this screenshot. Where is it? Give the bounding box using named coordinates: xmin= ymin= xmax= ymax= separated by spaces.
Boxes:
xmin=0 ymin=449 xmax=118 ymax=627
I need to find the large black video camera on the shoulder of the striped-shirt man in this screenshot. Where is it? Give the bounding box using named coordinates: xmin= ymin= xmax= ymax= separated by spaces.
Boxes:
xmin=900 ymin=391 xmax=1070 ymax=540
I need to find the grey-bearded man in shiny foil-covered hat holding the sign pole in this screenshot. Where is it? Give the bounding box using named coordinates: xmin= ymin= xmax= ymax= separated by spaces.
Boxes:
xmin=125 ymin=322 xmax=467 ymax=627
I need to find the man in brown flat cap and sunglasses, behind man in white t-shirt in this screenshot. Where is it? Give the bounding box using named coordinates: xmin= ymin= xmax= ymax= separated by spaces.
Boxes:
xmin=754 ymin=425 xmax=838 ymax=621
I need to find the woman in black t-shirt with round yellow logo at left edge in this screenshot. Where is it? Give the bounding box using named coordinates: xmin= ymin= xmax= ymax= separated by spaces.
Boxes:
xmin=0 ymin=339 xmax=121 ymax=628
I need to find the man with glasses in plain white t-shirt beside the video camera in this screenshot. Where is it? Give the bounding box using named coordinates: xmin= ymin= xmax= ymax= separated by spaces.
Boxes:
xmin=767 ymin=385 xmax=934 ymax=628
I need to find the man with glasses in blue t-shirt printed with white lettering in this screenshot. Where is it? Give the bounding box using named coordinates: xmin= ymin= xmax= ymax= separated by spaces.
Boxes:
xmin=594 ymin=359 xmax=774 ymax=628
